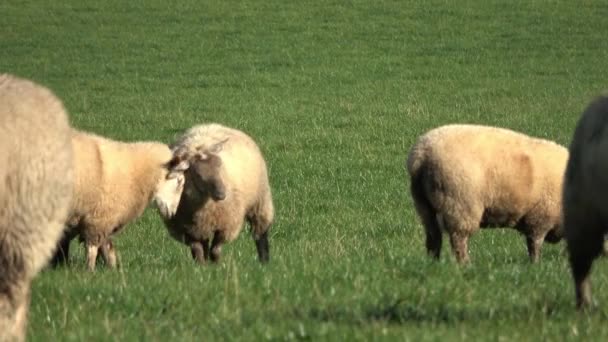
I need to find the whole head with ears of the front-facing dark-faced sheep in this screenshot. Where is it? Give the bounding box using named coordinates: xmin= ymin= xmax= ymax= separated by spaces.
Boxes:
xmin=166 ymin=139 xmax=227 ymax=201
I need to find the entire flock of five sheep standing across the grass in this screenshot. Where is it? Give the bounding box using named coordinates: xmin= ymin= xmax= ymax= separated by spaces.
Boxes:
xmin=0 ymin=74 xmax=608 ymax=340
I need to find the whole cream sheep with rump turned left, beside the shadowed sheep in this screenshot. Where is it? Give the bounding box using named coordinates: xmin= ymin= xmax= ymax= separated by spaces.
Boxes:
xmin=406 ymin=124 xmax=568 ymax=264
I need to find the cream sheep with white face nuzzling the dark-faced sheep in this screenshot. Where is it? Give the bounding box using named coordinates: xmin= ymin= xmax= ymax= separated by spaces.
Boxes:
xmin=53 ymin=129 xmax=184 ymax=271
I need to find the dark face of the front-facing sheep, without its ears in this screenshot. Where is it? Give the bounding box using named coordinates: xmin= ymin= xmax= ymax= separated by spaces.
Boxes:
xmin=188 ymin=153 xmax=226 ymax=201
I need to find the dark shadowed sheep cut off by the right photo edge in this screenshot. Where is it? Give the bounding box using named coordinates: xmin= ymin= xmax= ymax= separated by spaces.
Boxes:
xmin=563 ymin=96 xmax=608 ymax=309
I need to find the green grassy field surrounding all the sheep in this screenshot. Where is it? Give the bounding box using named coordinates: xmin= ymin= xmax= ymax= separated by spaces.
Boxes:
xmin=0 ymin=0 xmax=608 ymax=341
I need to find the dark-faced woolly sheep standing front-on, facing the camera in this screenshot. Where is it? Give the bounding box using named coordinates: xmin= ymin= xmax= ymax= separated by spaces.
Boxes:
xmin=158 ymin=124 xmax=274 ymax=264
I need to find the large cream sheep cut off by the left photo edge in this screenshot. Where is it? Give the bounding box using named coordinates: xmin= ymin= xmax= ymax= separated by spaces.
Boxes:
xmin=0 ymin=74 xmax=73 ymax=341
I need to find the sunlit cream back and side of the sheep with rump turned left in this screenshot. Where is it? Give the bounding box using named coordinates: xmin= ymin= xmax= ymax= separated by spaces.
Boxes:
xmin=420 ymin=125 xmax=564 ymax=212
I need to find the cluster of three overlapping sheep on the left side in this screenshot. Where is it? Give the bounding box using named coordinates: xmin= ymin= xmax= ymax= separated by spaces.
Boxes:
xmin=0 ymin=74 xmax=274 ymax=341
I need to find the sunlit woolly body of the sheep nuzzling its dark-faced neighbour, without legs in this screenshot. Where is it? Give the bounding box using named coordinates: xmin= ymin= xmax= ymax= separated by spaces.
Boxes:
xmin=70 ymin=132 xmax=172 ymax=228
